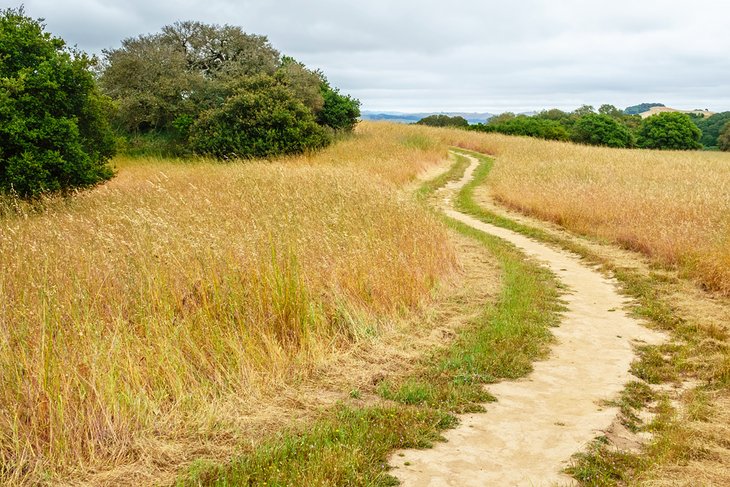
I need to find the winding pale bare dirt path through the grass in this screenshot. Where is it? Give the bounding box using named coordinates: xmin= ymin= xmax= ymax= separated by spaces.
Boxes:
xmin=391 ymin=158 xmax=662 ymax=487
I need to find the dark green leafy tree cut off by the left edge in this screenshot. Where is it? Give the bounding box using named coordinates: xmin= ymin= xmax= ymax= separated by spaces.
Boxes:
xmin=0 ymin=8 xmax=114 ymax=197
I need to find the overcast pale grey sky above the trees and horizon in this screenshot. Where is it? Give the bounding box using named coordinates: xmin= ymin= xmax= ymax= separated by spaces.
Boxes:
xmin=15 ymin=0 xmax=730 ymax=113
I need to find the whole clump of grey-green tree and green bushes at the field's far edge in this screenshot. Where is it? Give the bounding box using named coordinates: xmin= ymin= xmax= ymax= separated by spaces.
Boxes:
xmin=100 ymin=22 xmax=360 ymax=157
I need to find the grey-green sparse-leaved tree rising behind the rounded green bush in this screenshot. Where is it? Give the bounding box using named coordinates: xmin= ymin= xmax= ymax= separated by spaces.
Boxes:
xmin=100 ymin=22 xmax=279 ymax=131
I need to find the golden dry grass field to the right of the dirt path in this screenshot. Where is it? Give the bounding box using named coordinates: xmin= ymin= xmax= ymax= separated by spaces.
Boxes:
xmin=422 ymin=130 xmax=730 ymax=295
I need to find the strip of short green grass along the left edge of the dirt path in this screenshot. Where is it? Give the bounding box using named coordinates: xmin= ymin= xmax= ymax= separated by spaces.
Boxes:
xmin=177 ymin=151 xmax=562 ymax=486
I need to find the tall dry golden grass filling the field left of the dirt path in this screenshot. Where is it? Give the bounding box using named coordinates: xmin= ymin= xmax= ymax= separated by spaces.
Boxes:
xmin=0 ymin=125 xmax=454 ymax=483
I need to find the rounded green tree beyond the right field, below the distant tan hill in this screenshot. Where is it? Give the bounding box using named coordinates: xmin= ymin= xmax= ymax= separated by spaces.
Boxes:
xmin=637 ymin=112 xmax=702 ymax=150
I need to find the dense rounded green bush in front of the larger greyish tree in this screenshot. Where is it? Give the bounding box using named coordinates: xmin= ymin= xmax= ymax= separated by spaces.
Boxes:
xmin=190 ymin=76 xmax=330 ymax=158
